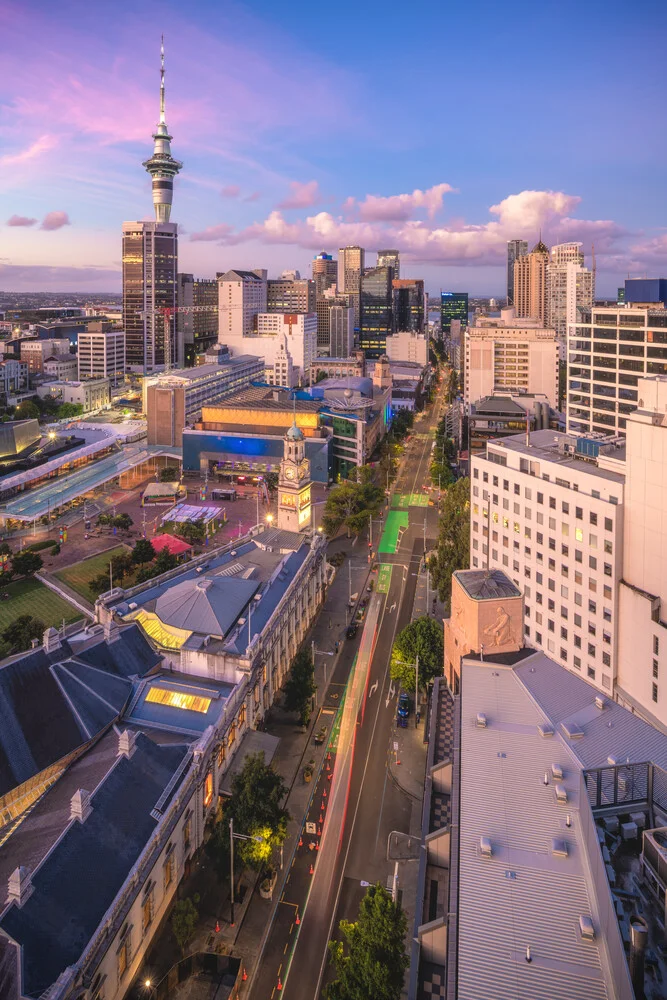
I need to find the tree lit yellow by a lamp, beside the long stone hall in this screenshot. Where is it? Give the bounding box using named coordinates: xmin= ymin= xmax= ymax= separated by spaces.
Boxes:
xmin=221 ymin=751 xmax=289 ymax=871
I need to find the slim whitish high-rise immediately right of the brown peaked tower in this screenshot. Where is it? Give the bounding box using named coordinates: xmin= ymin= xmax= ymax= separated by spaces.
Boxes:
xmin=546 ymin=243 xmax=594 ymax=360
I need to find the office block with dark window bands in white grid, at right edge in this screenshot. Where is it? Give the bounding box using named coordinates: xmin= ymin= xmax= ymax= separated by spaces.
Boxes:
xmin=567 ymin=303 xmax=667 ymax=435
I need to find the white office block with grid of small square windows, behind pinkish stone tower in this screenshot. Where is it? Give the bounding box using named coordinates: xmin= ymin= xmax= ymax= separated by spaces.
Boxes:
xmin=470 ymin=430 xmax=624 ymax=694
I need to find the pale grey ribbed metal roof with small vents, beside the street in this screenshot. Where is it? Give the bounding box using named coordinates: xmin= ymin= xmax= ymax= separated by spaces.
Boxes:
xmin=458 ymin=660 xmax=620 ymax=1000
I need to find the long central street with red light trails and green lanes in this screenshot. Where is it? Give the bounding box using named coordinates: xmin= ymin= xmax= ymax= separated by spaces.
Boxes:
xmin=251 ymin=376 xmax=442 ymax=1000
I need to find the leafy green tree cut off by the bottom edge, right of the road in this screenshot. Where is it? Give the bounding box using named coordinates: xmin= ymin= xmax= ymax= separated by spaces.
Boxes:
xmin=325 ymin=883 xmax=409 ymax=1000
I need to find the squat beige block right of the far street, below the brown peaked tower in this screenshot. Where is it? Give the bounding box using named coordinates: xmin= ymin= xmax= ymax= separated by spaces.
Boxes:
xmin=463 ymin=309 xmax=558 ymax=411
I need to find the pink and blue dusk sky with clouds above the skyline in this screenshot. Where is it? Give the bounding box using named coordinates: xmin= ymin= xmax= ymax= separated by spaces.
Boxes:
xmin=0 ymin=2 xmax=667 ymax=297
